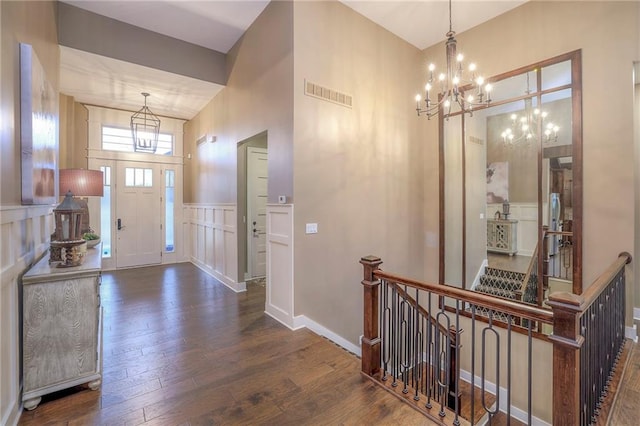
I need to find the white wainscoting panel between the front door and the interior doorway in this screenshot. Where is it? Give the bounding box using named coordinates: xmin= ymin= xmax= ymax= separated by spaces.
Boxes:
xmin=183 ymin=204 xmax=247 ymax=292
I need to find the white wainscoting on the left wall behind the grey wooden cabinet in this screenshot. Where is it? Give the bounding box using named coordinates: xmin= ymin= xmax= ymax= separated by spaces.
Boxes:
xmin=0 ymin=206 xmax=54 ymax=425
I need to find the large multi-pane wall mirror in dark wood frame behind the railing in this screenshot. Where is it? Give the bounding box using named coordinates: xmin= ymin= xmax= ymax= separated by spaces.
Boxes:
xmin=439 ymin=50 xmax=582 ymax=304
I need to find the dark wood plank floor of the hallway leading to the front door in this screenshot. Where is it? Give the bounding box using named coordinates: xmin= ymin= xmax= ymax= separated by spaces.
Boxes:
xmin=19 ymin=264 xmax=432 ymax=425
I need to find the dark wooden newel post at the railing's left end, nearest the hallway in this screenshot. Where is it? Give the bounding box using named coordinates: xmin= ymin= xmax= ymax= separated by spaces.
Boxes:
xmin=360 ymin=256 xmax=382 ymax=376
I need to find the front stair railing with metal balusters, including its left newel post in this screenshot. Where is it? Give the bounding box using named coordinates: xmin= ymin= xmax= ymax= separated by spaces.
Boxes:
xmin=360 ymin=256 xmax=553 ymax=424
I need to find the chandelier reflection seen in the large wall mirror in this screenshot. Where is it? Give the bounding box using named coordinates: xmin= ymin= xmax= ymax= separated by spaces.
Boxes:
xmin=500 ymin=73 xmax=560 ymax=145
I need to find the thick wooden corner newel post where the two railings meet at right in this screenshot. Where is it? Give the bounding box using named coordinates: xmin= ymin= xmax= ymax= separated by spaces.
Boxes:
xmin=547 ymin=293 xmax=584 ymax=425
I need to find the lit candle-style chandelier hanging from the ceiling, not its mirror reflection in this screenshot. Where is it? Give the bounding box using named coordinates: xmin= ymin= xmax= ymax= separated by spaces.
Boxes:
xmin=416 ymin=0 xmax=492 ymax=119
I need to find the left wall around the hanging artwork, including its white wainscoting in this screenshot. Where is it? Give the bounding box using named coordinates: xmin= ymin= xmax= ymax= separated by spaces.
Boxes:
xmin=0 ymin=1 xmax=60 ymax=424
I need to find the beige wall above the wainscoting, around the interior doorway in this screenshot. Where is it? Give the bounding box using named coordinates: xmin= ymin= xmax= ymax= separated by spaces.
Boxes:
xmin=185 ymin=2 xmax=293 ymax=203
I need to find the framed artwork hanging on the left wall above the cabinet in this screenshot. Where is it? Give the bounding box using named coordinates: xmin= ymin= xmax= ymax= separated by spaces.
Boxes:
xmin=20 ymin=43 xmax=58 ymax=204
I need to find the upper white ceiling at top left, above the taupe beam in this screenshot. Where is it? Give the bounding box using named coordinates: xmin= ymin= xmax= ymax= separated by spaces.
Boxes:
xmin=63 ymin=0 xmax=269 ymax=53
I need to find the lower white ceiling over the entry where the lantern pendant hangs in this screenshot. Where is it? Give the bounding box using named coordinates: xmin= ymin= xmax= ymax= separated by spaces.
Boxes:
xmin=60 ymin=46 xmax=223 ymax=120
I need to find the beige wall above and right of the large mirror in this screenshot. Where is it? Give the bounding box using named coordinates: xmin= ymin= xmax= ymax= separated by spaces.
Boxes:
xmin=424 ymin=1 xmax=640 ymax=302
